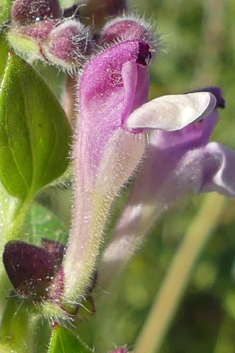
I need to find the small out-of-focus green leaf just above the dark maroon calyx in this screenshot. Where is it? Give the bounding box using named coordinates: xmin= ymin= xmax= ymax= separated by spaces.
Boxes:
xmin=25 ymin=203 xmax=68 ymax=246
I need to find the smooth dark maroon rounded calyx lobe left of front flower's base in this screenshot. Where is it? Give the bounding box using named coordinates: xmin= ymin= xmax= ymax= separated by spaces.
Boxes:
xmin=3 ymin=240 xmax=55 ymax=299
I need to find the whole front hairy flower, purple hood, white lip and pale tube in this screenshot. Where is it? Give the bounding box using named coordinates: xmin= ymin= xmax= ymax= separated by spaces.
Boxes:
xmin=63 ymin=17 xmax=215 ymax=302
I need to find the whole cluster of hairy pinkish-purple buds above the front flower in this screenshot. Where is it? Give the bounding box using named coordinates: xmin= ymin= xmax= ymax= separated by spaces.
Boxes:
xmin=8 ymin=0 xmax=157 ymax=75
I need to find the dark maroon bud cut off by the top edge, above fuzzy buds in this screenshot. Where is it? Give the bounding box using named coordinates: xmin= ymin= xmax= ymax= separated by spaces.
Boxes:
xmin=12 ymin=0 xmax=60 ymax=25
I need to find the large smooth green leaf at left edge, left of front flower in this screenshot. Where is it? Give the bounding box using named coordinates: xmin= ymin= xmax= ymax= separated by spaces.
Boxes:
xmin=0 ymin=53 xmax=71 ymax=200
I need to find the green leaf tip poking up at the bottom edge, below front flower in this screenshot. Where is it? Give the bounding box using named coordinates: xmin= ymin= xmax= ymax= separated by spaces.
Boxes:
xmin=48 ymin=324 xmax=94 ymax=353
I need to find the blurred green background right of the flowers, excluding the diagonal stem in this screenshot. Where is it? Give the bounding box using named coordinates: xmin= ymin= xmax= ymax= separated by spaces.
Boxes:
xmin=2 ymin=0 xmax=235 ymax=353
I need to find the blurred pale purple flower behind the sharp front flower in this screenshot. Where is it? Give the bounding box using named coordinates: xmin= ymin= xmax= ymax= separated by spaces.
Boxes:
xmin=99 ymin=87 xmax=235 ymax=283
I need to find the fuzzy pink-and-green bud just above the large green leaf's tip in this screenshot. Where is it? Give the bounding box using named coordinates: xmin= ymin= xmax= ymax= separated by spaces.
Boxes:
xmin=8 ymin=19 xmax=92 ymax=73
